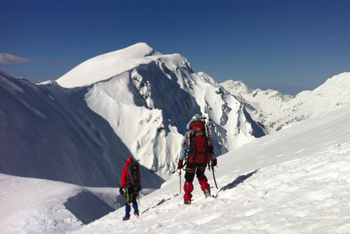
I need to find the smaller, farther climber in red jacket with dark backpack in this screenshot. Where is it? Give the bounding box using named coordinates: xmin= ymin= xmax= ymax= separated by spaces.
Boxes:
xmin=119 ymin=157 xmax=142 ymax=221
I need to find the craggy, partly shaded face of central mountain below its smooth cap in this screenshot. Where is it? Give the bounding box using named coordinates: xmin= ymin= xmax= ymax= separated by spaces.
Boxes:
xmin=85 ymin=51 xmax=255 ymax=179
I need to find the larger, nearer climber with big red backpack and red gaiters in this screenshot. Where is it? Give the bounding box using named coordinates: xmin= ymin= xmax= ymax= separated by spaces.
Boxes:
xmin=178 ymin=114 xmax=217 ymax=205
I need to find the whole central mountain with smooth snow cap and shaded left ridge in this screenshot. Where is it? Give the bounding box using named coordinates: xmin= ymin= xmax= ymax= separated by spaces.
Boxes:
xmin=0 ymin=43 xmax=261 ymax=187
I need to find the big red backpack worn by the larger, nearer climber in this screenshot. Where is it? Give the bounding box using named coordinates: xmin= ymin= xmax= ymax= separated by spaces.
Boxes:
xmin=187 ymin=120 xmax=211 ymax=163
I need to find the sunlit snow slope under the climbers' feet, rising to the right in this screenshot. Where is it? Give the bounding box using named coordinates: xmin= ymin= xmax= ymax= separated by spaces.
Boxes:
xmin=74 ymin=99 xmax=350 ymax=234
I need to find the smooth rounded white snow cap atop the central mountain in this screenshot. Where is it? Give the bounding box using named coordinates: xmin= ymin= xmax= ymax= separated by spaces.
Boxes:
xmin=57 ymin=43 xmax=158 ymax=88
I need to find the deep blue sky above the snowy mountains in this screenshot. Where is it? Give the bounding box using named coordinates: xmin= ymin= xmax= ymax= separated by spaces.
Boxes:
xmin=0 ymin=0 xmax=350 ymax=94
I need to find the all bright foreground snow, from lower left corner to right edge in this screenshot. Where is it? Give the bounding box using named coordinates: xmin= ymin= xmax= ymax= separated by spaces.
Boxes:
xmin=0 ymin=103 xmax=350 ymax=234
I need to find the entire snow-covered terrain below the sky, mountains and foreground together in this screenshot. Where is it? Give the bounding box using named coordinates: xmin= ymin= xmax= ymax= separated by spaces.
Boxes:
xmin=0 ymin=43 xmax=350 ymax=233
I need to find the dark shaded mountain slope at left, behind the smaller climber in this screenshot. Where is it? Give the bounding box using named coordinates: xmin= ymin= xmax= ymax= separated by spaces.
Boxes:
xmin=0 ymin=73 xmax=163 ymax=187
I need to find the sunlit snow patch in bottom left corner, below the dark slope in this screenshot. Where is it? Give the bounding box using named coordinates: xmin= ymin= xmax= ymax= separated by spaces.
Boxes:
xmin=0 ymin=174 xmax=82 ymax=234
